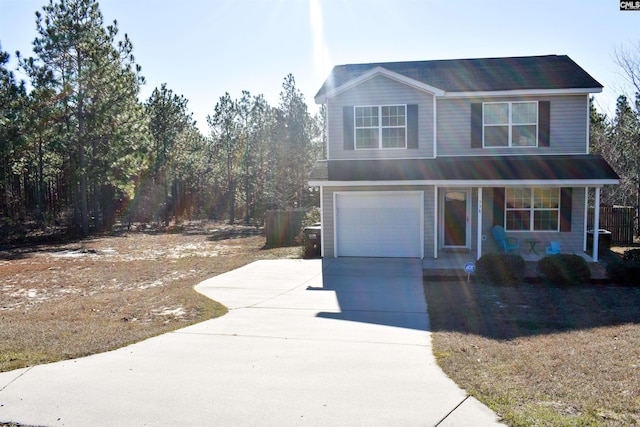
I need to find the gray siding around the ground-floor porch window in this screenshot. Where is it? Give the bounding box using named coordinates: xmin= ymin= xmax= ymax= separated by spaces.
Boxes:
xmin=476 ymin=188 xmax=585 ymax=255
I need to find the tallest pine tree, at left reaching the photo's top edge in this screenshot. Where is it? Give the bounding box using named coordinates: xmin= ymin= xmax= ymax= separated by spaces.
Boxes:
xmin=33 ymin=0 xmax=144 ymax=235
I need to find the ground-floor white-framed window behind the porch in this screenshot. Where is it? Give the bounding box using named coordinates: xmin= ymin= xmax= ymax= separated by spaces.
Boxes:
xmin=505 ymin=188 xmax=560 ymax=231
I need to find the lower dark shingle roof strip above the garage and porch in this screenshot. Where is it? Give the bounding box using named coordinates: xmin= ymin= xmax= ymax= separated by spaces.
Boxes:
xmin=309 ymin=154 xmax=619 ymax=183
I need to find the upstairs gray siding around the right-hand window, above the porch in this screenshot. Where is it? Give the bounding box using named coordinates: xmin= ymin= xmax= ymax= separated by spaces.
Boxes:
xmin=437 ymin=94 xmax=589 ymax=156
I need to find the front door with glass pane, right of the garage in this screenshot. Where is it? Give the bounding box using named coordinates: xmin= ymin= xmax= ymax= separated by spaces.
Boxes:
xmin=440 ymin=189 xmax=471 ymax=249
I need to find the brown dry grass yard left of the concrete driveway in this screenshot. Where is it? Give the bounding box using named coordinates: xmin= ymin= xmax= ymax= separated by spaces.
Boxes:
xmin=0 ymin=223 xmax=301 ymax=372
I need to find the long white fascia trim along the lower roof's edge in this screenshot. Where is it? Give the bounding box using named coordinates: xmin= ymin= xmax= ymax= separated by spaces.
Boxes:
xmin=308 ymin=179 xmax=619 ymax=187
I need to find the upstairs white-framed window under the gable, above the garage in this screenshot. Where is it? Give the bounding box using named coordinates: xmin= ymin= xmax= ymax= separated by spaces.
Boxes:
xmin=355 ymin=105 xmax=407 ymax=150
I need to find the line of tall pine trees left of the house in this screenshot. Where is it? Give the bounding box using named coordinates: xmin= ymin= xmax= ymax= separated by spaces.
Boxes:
xmin=0 ymin=0 xmax=324 ymax=238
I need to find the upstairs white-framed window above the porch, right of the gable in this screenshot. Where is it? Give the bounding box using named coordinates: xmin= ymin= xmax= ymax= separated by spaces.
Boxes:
xmin=482 ymin=102 xmax=538 ymax=147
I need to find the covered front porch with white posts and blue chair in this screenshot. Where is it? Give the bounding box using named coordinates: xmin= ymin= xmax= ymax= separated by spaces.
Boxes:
xmin=436 ymin=186 xmax=600 ymax=269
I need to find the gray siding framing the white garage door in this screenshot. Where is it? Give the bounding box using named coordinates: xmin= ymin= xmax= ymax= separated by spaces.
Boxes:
xmin=322 ymin=186 xmax=434 ymax=258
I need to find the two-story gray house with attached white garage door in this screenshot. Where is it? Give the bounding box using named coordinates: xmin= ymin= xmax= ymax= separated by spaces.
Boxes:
xmin=309 ymin=55 xmax=618 ymax=260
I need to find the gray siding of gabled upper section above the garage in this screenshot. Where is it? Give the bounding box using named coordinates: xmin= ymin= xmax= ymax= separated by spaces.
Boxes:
xmin=327 ymin=76 xmax=434 ymax=160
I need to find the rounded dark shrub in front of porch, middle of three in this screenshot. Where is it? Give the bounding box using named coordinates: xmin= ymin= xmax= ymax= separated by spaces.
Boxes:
xmin=538 ymin=254 xmax=591 ymax=286
